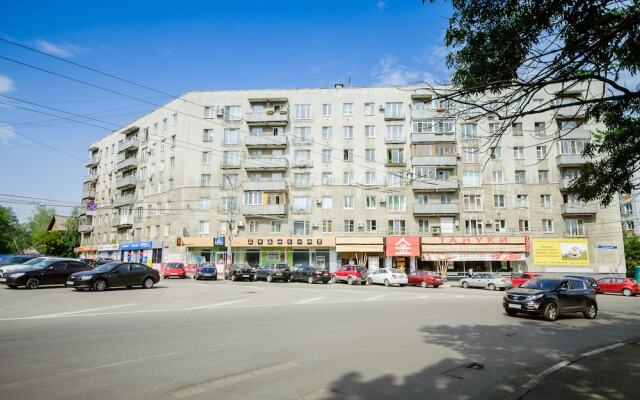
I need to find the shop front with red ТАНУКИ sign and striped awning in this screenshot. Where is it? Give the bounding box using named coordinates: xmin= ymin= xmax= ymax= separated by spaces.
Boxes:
xmin=418 ymin=236 xmax=531 ymax=273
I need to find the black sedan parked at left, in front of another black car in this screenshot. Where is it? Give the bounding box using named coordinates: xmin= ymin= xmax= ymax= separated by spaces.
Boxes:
xmin=67 ymin=262 xmax=160 ymax=292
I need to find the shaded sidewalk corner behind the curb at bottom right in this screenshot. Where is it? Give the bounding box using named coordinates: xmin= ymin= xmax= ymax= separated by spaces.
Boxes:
xmin=522 ymin=343 xmax=640 ymax=400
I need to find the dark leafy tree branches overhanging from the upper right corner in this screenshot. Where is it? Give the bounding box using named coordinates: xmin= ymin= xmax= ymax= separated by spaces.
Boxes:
xmin=423 ymin=0 xmax=640 ymax=205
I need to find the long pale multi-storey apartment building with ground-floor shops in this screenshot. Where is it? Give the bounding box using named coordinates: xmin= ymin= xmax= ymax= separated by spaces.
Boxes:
xmin=79 ymin=86 xmax=624 ymax=273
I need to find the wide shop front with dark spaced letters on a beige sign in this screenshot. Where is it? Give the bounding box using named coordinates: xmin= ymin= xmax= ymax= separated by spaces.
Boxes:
xmin=232 ymin=236 xmax=335 ymax=270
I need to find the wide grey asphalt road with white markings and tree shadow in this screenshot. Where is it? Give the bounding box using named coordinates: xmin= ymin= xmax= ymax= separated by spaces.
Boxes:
xmin=0 ymin=279 xmax=640 ymax=400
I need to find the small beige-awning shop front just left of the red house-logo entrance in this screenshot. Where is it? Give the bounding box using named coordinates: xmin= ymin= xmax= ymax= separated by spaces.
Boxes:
xmin=331 ymin=236 xmax=385 ymax=271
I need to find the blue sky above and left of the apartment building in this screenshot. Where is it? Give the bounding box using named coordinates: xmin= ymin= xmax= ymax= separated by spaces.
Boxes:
xmin=0 ymin=0 xmax=450 ymax=220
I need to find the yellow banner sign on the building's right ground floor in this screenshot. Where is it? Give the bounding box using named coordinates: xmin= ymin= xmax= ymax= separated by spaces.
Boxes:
xmin=533 ymin=238 xmax=589 ymax=266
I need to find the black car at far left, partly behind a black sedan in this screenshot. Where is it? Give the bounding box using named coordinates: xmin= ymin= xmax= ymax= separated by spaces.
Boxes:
xmin=2 ymin=258 xmax=91 ymax=289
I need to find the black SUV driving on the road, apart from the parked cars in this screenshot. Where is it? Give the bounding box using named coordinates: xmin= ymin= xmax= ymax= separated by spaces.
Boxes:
xmin=502 ymin=278 xmax=598 ymax=321
